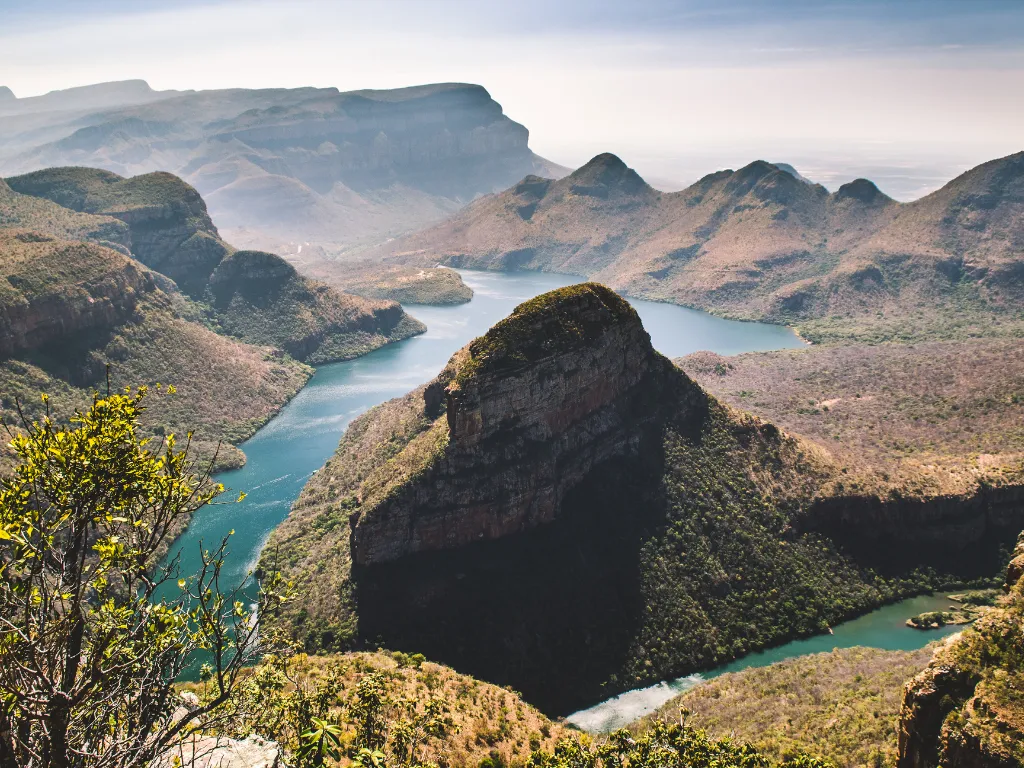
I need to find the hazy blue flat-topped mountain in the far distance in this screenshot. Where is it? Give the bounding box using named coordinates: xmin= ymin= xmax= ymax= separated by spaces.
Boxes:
xmin=0 ymin=81 xmax=566 ymax=253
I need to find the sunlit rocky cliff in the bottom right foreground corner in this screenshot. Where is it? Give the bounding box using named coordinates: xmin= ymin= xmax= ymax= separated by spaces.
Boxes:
xmin=898 ymin=534 xmax=1024 ymax=768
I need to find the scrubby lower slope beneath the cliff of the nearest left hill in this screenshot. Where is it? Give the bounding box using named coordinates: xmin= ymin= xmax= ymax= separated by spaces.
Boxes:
xmin=0 ymin=293 xmax=312 ymax=469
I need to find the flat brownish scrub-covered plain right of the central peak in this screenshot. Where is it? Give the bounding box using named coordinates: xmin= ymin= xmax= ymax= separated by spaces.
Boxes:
xmin=678 ymin=339 xmax=1024 ymax=494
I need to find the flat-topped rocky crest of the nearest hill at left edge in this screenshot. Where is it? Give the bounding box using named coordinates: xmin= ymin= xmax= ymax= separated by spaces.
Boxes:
xmin=0 ymin=230 xmax=155 ymax=357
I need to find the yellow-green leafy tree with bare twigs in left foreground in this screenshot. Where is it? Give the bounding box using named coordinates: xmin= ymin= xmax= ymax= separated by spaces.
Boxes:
xmin=0 ymin=387 xmax=284 ymax=768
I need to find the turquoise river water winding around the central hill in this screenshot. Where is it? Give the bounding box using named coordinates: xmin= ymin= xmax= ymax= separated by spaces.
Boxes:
xmin=155 ymin=270 xmax=954 ymax=730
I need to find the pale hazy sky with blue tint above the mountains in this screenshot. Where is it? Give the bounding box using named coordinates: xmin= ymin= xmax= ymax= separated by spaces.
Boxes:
xmin=0 ymin=0 xmax=1024 ymax=199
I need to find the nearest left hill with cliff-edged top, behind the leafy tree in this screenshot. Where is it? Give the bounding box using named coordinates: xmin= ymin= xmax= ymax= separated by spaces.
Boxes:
xmin=0 ymin=229 xmax=310 ymax=468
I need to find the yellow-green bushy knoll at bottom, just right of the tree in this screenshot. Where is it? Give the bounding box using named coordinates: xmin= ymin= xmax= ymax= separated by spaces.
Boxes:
xmin=186 ymin=651 xmax=566 ymax=768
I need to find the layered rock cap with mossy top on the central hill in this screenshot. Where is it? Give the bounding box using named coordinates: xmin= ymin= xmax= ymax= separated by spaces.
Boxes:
xmin=352 ymin=284 xmax=688 ymax=566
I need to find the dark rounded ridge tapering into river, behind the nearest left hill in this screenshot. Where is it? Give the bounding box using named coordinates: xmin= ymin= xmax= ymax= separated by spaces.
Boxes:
xmin=7 ymin=168 xmax=424 ymax=364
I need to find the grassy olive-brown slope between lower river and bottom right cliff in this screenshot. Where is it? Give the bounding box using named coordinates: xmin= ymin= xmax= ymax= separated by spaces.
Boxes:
xmin=643 ymin=645 xmax=935 ymax=768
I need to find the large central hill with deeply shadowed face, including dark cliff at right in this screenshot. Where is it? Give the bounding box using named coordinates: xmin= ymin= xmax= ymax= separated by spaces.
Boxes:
xmin=262 ymin=284 xmax=1020 ymax=712
